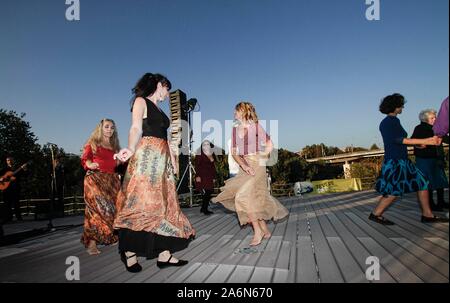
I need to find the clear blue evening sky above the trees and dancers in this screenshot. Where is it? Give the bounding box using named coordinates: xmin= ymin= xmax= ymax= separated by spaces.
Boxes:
xmin=0 ymin=0 xmax=449 ymax=153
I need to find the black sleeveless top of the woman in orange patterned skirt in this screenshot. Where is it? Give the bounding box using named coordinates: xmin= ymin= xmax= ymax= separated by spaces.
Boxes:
xmin=142 ymin=98 xmax=170 ymax=140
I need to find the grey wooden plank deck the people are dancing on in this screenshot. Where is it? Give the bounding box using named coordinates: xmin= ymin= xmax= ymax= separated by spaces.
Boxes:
xmin=0 ymin=191 xmax=449 ymax=283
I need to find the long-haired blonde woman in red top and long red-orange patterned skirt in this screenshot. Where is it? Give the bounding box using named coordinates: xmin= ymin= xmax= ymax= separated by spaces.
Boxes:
xmin=81 ymin=119 xmax=120 ymax=255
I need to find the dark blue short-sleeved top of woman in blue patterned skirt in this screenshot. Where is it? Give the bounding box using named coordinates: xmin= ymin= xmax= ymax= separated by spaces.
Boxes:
xmin=380 ymin=116 xmax=408 ymax=160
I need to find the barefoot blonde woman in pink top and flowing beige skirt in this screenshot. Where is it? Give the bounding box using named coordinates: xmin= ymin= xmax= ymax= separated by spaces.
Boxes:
xmin=212 ymin=102 xmax=288 ymax=246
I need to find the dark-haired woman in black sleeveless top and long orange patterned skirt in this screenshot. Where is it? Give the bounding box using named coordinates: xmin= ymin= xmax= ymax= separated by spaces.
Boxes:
xmin=114 ymin=73 xmax=195 ymax=272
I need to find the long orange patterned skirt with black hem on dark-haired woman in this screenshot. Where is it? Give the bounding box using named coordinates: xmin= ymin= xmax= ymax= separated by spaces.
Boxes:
xmin=114 ymin=137 xmax=195 ymax=259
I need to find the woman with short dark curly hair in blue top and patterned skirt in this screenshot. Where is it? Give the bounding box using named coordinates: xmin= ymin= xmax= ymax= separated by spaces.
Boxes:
xmin=369 ymin=94 xmax=448 ymax=225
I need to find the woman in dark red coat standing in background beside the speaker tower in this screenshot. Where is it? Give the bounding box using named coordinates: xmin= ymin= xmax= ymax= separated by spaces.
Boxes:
xmin=195 ymin=140 xmax=216 ymax=215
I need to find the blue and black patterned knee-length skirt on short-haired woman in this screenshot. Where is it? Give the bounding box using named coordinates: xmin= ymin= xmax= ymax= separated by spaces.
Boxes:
xmin=375 ymin=159 xmax=429 ymax=196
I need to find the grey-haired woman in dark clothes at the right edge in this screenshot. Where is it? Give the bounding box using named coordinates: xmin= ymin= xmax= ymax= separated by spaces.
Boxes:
xmin=412 ymin=109 xmax=448 ymax=211
